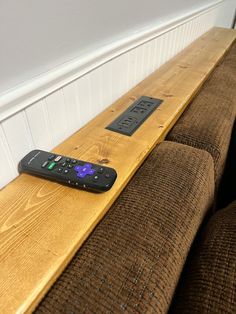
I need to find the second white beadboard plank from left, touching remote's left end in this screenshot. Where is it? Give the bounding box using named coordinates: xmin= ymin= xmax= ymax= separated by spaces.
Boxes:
xmin=2 ymin=111 xmax=34 ymax=169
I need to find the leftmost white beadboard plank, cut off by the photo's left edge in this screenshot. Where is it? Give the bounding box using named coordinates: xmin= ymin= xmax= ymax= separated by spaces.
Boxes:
xmin=0 ymin=125 xmax=17 ymax=189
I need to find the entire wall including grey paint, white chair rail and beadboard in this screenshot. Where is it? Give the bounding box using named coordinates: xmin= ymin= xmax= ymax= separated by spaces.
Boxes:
xmin=0 ymin=0 xmax=235 ymax=188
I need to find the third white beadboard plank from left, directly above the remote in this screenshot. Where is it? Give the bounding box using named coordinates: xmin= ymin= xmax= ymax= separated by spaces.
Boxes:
xmin=25 ymin=100 xmax=53 ymax=150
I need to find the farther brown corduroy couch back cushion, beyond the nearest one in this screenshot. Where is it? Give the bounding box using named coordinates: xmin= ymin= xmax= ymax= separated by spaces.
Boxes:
xmin=166 ymin=43 xmax=236 ymax=186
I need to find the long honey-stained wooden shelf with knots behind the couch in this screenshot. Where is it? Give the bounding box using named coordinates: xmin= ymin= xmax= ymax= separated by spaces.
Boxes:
xmin=0 ymin=28 xmax=236 ymax=313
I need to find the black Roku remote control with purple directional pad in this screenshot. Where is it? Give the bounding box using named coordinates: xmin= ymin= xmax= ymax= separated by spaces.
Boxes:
xmin=19 ymin=150 xmax=117 ymax=192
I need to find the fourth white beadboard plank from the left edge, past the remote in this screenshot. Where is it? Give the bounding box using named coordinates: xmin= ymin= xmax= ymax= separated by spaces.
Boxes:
xmin=45 ymin=90 xmax=70 ymax=147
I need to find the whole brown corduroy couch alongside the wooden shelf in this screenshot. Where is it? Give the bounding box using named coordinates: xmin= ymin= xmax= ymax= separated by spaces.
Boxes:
xmin=36 ymin=45 xmax=236 ymax=313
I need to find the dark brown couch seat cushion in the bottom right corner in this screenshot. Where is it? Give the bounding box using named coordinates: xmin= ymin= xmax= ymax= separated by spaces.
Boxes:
xmin=170 ymin=201 xmax=236 ymax=314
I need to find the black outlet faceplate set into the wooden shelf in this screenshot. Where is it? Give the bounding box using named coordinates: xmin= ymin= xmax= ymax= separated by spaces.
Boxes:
xmin=106 ymin=96 xmax=163 ymax=136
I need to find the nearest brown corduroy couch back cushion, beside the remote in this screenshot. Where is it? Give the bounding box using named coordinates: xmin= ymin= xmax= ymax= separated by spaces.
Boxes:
xmin=36 ymin=142 xmax=214 ymax=314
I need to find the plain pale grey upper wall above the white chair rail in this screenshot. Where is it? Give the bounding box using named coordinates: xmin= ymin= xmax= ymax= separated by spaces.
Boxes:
xmin=0 ymin=0 xmax=233 ymax=94
